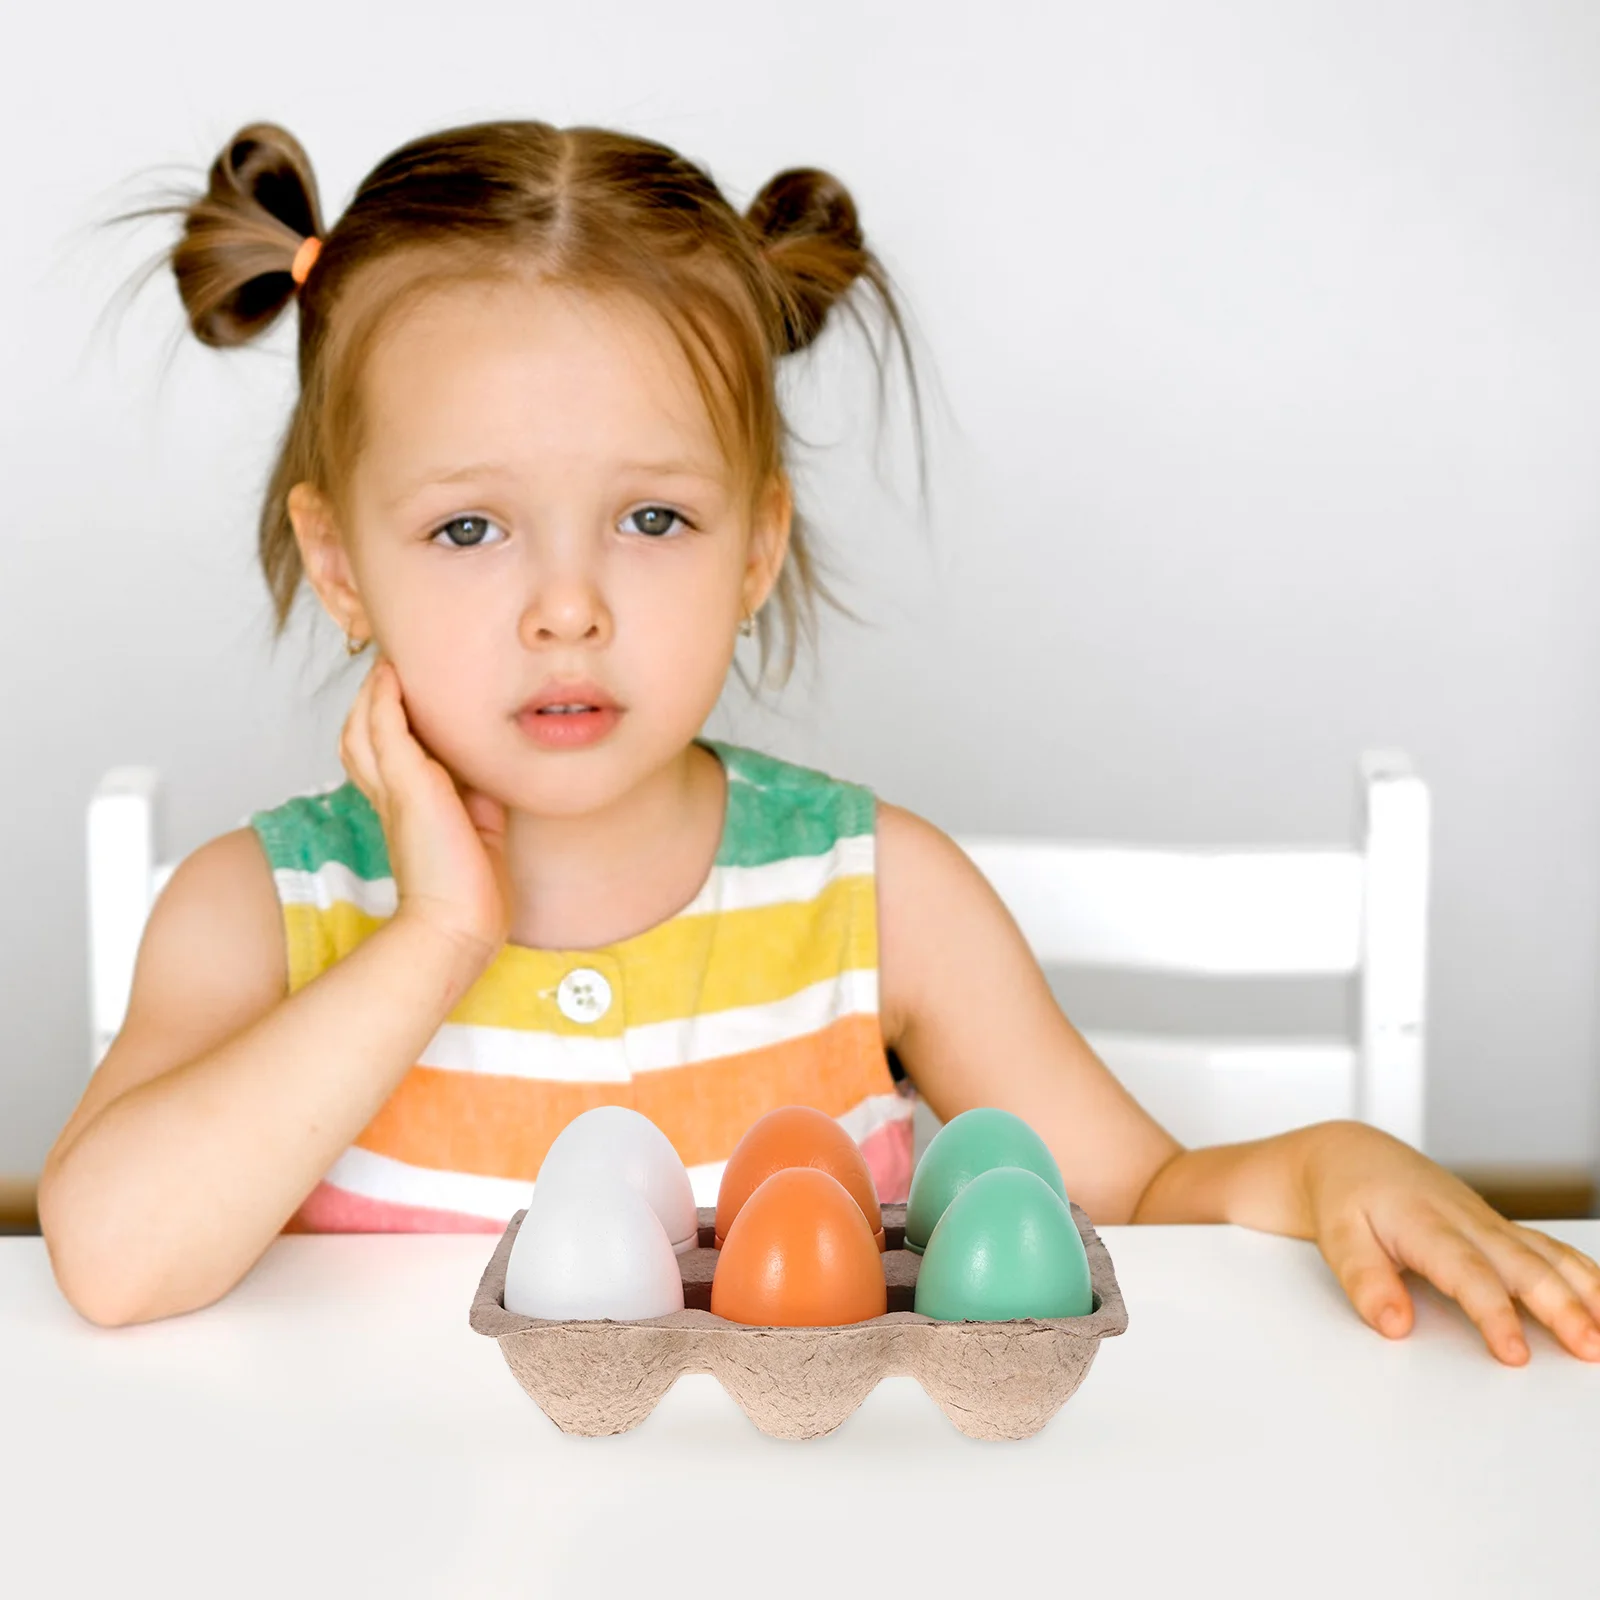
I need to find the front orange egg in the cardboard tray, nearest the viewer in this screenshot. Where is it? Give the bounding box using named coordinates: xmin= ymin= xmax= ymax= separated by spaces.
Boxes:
xmin=710 ymin=1166 xmax=890 ymax=1328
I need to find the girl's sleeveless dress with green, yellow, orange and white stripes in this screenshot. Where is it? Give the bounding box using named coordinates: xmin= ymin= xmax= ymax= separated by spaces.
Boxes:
xmin=248 ymin=738 xmax=912 ymax=1232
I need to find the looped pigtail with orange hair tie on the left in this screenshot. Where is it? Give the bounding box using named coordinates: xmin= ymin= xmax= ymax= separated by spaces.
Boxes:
xmin=171 ymin=123 xmax=322 ymax=349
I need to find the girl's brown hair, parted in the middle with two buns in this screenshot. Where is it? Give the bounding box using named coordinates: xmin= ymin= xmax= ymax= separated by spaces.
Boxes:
xmin=130 ymin=122 xmax=926 ymax=682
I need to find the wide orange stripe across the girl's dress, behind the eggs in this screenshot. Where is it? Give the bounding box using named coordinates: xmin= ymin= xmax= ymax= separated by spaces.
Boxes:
xmin=355 ymin=1014 xmax=896 ymax=1181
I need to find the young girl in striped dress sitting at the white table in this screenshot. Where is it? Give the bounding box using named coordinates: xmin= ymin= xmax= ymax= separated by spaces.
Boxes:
xmin=38 ymin=122 xmax=1600 ymax=1363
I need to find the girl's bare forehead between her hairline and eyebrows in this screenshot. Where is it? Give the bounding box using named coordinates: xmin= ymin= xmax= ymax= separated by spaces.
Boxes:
xmin=360 ymin=280 xmax=723 ymax=477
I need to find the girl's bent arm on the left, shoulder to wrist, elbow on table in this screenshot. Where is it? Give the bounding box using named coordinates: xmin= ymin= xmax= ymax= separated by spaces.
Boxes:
xmin=38 ymin=829 xmax=486 ymax=1326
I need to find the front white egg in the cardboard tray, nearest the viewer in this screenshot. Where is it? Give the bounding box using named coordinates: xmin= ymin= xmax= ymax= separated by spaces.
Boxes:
xmin=502 ymin=1178 xmax=683 ymax=1322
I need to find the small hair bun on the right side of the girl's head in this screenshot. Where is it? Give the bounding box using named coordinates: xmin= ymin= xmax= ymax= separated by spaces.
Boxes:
xmin=746 ymin=166 xmax=870 ymax=354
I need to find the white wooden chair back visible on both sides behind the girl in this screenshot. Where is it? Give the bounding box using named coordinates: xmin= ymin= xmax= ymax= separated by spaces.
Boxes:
xmin=88 ymin=750 xmax=1430 ymax=1149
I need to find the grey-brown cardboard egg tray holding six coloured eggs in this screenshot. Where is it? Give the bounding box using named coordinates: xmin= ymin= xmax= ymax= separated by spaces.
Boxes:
xmin=472 ymin=1205 xmax=1128 ymax=1438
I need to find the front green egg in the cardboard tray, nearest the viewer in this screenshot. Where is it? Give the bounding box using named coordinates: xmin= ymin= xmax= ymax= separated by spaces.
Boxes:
xmin=915 ymin=1164 xmax=1094 ymax=1322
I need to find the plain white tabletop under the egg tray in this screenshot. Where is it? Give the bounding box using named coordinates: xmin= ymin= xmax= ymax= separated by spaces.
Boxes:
xmin=0 ymin=1221 xmax=1600 ymax=1600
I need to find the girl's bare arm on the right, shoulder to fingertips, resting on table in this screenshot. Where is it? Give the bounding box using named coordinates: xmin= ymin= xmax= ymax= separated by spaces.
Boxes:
xmin=877 ymin=805 xmax=1600 ymax=1363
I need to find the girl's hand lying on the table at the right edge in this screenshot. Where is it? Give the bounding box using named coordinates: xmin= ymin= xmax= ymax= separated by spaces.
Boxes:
xmin=1304 ymin=1122 xmax=1600 ymax=1366
